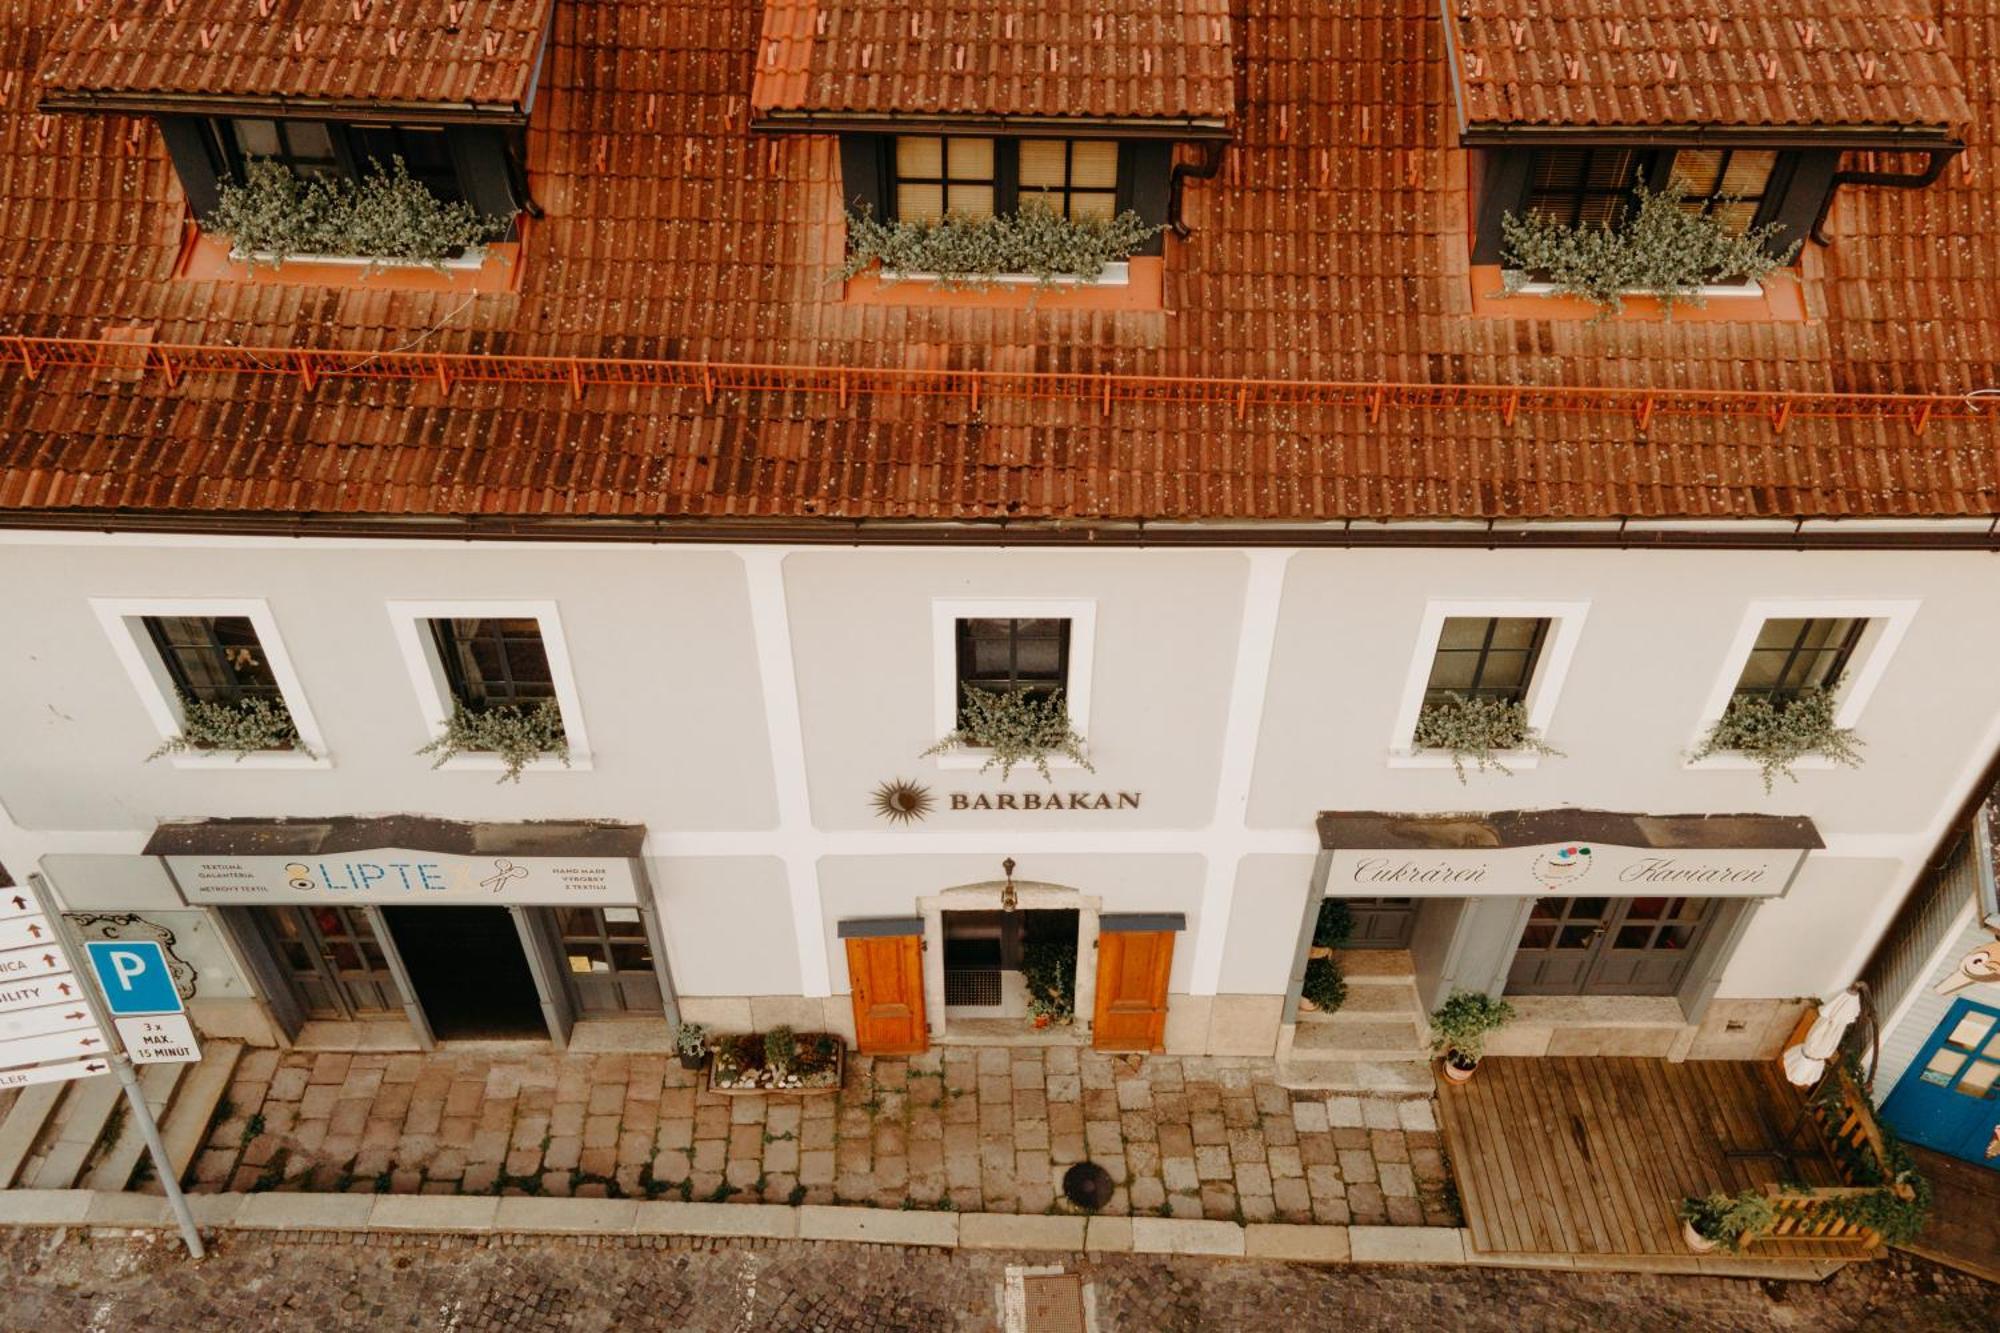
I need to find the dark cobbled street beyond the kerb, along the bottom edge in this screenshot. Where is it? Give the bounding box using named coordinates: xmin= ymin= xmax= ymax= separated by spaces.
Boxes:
xmin=0 ymin=1231 xmax=2000 ymax=1333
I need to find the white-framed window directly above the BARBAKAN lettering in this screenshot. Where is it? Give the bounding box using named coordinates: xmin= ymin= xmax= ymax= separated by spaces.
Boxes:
xmin=932 ymin=598 xmax=1096 ymax=769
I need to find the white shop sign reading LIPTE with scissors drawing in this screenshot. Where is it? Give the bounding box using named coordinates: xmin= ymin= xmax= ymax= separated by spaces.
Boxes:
xmin=166 ymin=847 xmax=638 ymax=907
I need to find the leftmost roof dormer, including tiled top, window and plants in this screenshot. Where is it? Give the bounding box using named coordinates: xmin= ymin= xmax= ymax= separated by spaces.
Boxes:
xmin=40 ymin=0 xmax=556 ymax=290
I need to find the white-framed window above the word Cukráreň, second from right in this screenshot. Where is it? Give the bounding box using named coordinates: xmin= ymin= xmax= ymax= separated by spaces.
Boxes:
xmin=1390 ymin=600 xmax=1588 ymax=769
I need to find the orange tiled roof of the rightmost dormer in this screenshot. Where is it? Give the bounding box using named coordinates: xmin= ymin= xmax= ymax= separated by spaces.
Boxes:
xmin=1444 ymin=0 xmax=1970 ymax=128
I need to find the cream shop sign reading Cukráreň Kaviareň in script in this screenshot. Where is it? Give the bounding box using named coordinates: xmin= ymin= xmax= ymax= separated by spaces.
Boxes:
xmin=1326 ymin=841 xmax=1806 ymax=899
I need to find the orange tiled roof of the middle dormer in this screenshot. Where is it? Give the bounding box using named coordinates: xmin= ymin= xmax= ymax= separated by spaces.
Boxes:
xmin=750 ymin=0 xmax=1234 ymax=118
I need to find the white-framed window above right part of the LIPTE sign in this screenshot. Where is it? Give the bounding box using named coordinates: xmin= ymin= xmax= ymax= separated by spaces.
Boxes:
xmin=390 ymin=602 xmax=590 ymax=773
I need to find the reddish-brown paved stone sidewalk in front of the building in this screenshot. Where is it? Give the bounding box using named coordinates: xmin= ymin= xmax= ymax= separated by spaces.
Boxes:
xmin=192 ymin=1047 xmax=1456 ymax=1225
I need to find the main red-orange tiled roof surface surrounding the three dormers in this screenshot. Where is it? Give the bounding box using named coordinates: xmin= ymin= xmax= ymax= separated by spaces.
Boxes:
xmin=0 ymin=0 xmax=2000 ymax=520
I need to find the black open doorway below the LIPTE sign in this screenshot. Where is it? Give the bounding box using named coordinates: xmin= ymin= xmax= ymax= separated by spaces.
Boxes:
xmin=382 ymin=907 xmax=548 ymax=1041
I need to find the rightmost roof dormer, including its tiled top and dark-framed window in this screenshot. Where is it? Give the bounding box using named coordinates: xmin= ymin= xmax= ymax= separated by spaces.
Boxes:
xmin=1442 ymin=0 xmax=1970 ymax=318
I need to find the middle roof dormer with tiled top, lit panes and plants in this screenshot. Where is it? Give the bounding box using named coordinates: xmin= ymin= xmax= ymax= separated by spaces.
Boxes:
xmin=752 ymin=0 xmax=1234 ymax=308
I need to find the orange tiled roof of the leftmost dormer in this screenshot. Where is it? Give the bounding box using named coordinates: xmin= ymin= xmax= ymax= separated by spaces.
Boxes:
xmin=39 ymin=0 xmax=556 ymax=112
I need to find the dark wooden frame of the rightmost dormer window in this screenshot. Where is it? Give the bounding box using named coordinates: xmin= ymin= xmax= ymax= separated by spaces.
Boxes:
xmin=1472 ymin=140 xmax=1840 ymax=264
